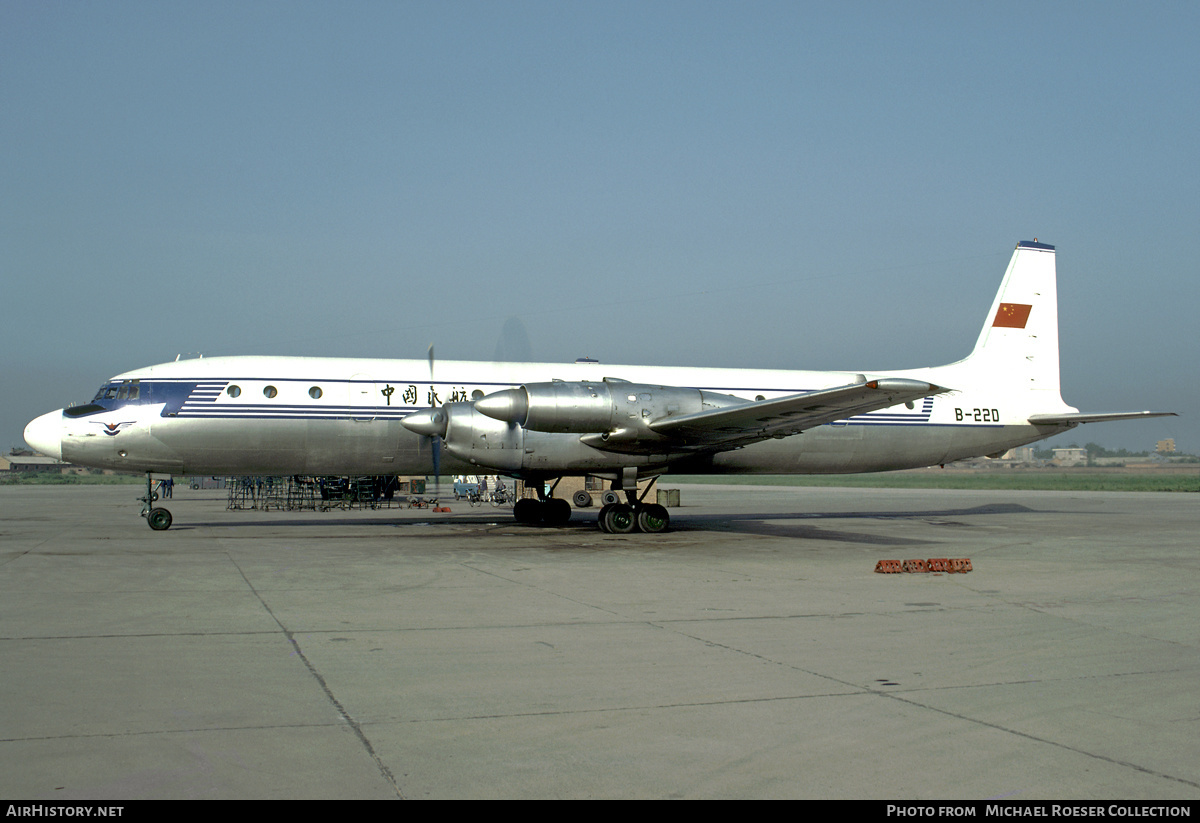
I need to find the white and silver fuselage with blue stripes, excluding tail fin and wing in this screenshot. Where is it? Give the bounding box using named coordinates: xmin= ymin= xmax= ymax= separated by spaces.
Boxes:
xmin=31 ymin=356 xmax=1061 ymax=475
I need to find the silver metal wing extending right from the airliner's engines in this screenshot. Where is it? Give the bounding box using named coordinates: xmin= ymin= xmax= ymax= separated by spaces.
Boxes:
xmin=649 ymin=377 xmax=948 ymax=450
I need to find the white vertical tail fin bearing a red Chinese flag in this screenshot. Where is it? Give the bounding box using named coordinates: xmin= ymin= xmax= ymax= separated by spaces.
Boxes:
xmin=961 ymin=240 xmax=1066 ymax=409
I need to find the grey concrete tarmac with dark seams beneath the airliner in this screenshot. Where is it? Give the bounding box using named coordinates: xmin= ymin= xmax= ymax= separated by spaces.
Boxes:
xmin=0 ymin=483 xmax=1200 ymax=801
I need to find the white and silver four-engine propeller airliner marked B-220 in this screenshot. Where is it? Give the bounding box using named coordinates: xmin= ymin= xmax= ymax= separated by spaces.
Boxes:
xmin=25 ymin=240 xmax=1170 ymax=533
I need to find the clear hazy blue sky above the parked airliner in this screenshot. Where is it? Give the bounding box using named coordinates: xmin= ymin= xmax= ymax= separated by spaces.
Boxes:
xmin=0 ymin=0 xmax=1200 ymax=452
